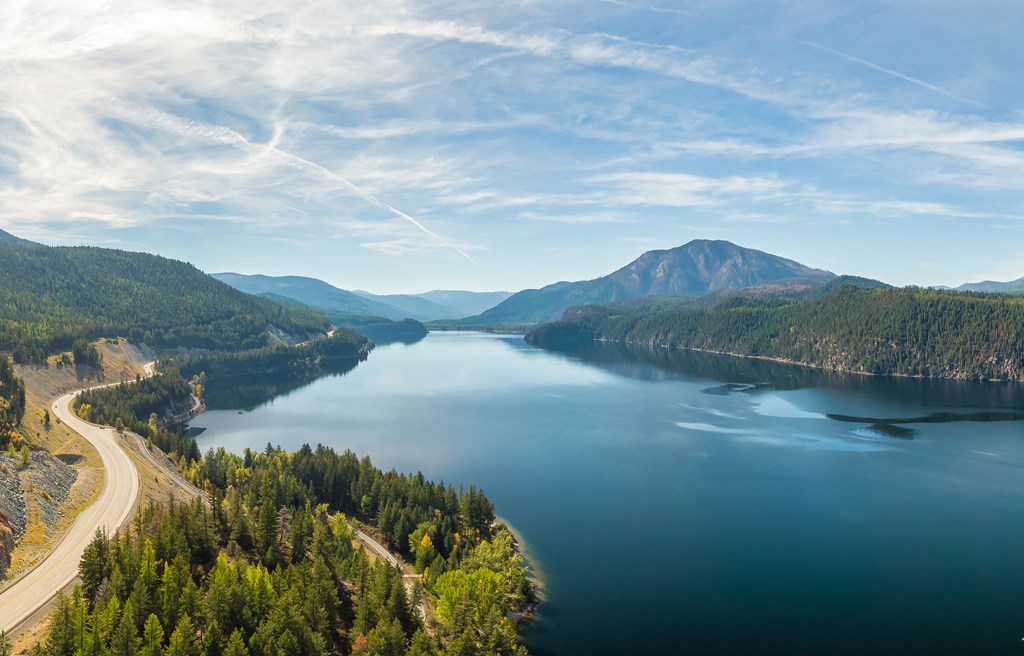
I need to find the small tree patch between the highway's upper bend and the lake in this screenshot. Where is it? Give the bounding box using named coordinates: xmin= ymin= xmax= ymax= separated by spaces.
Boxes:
xmin=74 ymin=371 xmax=200 ymax=464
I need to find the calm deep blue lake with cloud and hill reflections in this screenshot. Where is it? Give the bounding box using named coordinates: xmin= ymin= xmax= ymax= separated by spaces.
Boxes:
xmin=195 ymin=333 xmax=1024 ymax=655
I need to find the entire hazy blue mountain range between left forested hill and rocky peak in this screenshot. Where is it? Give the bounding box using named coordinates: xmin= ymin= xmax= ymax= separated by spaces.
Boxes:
xmin=211 ymin=273 xmax=511 ymax=322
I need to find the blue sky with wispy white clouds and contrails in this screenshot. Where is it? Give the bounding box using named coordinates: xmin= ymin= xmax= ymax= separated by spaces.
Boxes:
xmin=0 ymin=0 xmax=1024 ymax=293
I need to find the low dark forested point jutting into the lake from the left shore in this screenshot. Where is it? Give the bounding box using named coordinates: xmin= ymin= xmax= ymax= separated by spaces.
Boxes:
xmin=160 ymin=329 xmax=372 ymax=381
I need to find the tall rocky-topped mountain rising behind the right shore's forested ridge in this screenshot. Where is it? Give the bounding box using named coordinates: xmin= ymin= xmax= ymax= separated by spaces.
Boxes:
xmin=460 ymin=239 xmax=836 ymax=324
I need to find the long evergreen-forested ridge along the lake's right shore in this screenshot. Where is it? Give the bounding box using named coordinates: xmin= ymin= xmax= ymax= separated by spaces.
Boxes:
xmin=526 ymin=285 xmax=1024 ymax=381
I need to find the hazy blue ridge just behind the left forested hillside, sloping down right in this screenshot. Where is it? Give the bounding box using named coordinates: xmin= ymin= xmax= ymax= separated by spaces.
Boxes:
xmin=211 ymin=273 xmax=409 ymax=319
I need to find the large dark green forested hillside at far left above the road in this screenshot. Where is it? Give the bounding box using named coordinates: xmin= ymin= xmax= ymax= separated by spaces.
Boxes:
xmin=0 ymin=235 xmax=329 ymax=362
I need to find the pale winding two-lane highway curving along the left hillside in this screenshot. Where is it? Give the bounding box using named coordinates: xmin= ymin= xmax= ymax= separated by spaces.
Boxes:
xmin=0 ymin=388 xmax=140 ymax=633
